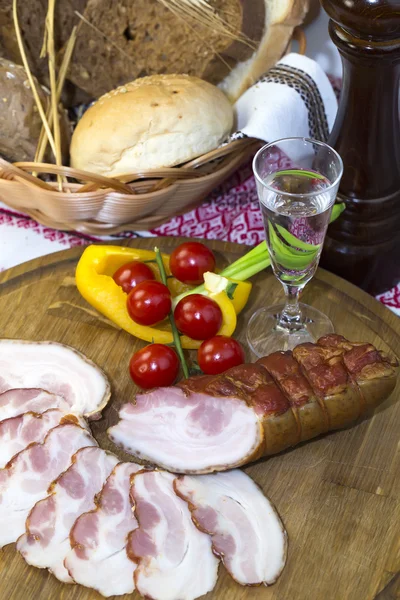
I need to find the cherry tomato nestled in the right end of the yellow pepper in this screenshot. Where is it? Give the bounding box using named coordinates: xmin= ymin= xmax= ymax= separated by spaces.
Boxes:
xmin=174 ymin=294 xmax=222 ymax=340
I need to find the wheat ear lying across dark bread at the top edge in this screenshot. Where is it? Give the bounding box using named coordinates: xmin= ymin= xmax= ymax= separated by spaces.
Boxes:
xmin=158 ymin=0 xmax=254 ymax=46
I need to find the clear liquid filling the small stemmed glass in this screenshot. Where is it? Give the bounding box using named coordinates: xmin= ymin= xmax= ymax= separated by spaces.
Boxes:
xmin=260 ymin=169 xmax=333 ymax=286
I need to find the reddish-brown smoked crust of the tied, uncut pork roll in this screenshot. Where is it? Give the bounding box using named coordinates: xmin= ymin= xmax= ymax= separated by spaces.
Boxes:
xmin=179 ymin=334 xmax=398 ymax=464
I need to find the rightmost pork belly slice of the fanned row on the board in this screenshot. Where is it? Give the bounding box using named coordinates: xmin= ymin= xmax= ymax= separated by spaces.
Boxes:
xmin=174 ymin=469 xmax=287 ymax=585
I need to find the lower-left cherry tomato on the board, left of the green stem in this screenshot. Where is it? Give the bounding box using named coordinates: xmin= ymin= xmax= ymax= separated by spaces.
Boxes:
xmin=129 ymin=344 xmax=179 ymax=389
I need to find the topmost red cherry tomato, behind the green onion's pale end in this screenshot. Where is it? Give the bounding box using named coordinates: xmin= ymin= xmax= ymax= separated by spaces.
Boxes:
xmin=169 ymin=242 xmax=215 ymax=285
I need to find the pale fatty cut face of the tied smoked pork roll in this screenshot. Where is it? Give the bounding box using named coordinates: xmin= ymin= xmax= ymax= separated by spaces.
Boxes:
xmin=108 ymin=387 xmax=264 ymax=473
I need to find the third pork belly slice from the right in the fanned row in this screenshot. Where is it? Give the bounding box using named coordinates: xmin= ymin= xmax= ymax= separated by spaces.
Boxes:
xmin=64 ymin=463 xmax=143 ymax=597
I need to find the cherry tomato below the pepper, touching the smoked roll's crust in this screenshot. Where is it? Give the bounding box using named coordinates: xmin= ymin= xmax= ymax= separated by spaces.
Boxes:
xmin=197 ymin=335 xmax=245 ymax=375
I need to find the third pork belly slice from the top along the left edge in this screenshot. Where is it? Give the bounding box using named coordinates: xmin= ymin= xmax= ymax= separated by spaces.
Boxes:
xmin=0 ymin=408 xmax=86 ymax=469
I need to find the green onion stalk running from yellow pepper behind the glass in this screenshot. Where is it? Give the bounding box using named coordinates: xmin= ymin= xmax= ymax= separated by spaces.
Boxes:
xmin=174 ymin=202 xmax=345 ymax=304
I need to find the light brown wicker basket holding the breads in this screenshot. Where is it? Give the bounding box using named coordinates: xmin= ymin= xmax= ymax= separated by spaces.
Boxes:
xmin=0 ymin=28 xmax=306 ymax=235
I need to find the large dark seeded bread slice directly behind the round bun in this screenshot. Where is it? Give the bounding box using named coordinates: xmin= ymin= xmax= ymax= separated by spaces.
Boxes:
xmin=65 ymin=0 xmax=265 ymax=97
